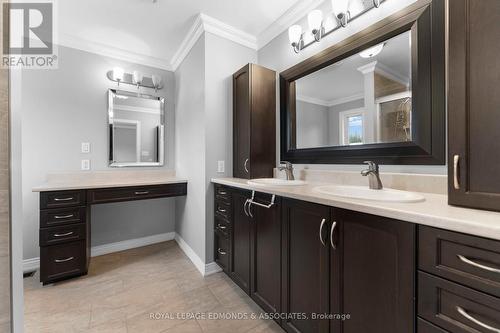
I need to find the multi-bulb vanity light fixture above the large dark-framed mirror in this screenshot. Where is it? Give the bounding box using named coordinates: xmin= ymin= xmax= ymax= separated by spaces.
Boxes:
xmin=288 ymin=0 xmax=387 ymax=53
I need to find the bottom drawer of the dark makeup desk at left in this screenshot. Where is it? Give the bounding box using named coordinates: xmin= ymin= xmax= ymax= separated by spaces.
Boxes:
xmin=40 ymin=241 xmax=87 ymax=283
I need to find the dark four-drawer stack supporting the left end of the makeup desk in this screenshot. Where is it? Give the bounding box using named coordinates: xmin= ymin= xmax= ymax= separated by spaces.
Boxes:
xmin=39 ymin=190 xmax=90 ymax=284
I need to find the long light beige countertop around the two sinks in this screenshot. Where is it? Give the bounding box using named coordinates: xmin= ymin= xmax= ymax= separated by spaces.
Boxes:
xmin=212 ymin=178 xmax=500 ymax=240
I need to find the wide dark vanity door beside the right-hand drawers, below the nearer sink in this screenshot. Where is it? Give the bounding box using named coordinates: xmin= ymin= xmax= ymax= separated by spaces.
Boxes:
xmin=331 ymin=209 xmax=415 ymax=333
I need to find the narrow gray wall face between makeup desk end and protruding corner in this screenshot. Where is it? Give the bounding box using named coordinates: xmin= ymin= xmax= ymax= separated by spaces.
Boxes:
xmin=175 ymin=36 xmax=206 ymax=260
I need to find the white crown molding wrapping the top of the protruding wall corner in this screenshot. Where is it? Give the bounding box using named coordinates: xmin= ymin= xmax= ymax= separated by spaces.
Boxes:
xmin=170 ymin=13 xmax=257 ymax=71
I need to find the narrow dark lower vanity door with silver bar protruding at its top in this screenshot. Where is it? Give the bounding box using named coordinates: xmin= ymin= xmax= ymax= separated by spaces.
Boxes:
xmin=249 ymin=193 xmax=281 ymax=313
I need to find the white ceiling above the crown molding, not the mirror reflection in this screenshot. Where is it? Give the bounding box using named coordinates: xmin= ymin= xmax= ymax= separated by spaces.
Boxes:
xmin=57 ymin=0 xmax=300 ymax=68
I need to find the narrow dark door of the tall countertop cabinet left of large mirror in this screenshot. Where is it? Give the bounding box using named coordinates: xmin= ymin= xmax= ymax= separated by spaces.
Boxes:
xmin=233 ymin=65 xmax=251 ymax=179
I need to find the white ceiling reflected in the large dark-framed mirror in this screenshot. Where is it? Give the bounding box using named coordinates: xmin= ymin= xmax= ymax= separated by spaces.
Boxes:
xmin=296 ymin=32 xmax=411 ymax=105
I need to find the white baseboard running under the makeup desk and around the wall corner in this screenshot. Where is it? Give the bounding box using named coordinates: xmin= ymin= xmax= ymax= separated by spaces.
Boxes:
xmin=23 ymin=232 xmax=222 ymax=276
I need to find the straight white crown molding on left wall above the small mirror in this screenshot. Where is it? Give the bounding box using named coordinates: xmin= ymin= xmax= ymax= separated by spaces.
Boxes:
xmin=58 ymin=33 xmax=172 ymax=71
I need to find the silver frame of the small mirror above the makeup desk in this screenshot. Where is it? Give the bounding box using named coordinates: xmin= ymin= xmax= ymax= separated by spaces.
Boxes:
xmin=108 ymin=89 xmax=165 ymax=168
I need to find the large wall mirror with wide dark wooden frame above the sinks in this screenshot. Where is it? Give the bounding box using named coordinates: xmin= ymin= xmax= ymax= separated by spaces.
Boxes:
xmin=281 ymin=0 xmax=445 ymax=164
